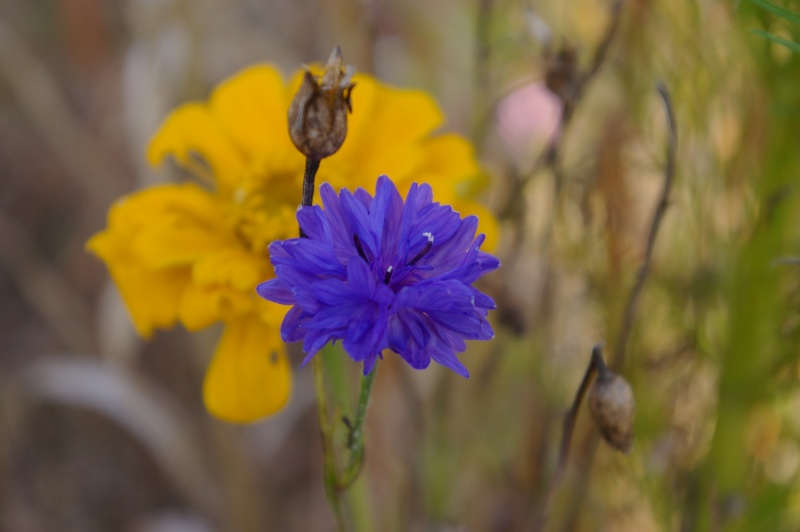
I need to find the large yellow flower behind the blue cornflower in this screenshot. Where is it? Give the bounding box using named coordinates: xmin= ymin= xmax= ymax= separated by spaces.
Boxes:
xmin=87 ymin=66 xmax=497 ymax=422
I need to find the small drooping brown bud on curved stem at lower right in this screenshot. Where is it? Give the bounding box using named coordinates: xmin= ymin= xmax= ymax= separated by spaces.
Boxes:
xmin=589 ymin=368 xmax=636 ymax=454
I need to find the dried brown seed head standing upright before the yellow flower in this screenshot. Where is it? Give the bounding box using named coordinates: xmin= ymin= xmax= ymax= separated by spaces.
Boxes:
xmin=289 ymin=46 xmax=353 ymax=160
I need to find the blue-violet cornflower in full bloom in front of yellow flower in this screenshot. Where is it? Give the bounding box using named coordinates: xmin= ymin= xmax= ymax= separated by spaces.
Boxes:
xmin=257 ymin=176 xmax=500 ymax=377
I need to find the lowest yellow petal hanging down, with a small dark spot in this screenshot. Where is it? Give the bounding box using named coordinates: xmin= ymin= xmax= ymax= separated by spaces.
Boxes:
xmin=203 ymin=316 xmax=292 ymax=423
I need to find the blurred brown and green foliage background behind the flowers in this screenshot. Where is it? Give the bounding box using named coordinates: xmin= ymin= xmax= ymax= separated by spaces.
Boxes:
xmin=0 ymin=0 xmax=800 ymax=532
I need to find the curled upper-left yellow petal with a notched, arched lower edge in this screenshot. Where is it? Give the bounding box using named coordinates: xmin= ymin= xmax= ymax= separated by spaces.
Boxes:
xmin=147 ymin=103 xmax=246 ymax=188
